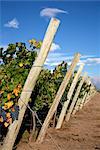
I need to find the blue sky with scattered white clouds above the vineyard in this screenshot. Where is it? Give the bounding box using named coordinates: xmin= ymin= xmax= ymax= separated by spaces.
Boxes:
xmin=0 ymin=1 xmax=100 ymax=88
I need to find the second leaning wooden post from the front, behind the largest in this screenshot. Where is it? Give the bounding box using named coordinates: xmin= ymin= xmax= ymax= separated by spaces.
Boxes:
xmin=37 ymin=53 xmax=80 ymax=143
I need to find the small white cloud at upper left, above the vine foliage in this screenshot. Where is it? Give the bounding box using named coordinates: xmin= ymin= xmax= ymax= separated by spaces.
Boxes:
xmin=4 ymin=18 xmax=19 ymax=29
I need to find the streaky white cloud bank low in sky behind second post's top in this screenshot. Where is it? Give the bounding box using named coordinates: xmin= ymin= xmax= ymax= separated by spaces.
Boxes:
xmin=45 ymin=51 xmax=100 ymax=68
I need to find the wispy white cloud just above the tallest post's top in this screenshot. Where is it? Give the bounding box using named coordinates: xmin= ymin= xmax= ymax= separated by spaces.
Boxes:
xmin=40 ymin=8 xmax=68 ymax=18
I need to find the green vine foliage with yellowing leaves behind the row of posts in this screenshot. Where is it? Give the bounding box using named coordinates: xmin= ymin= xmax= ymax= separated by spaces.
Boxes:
xmin=0 ymin=39 xmax=89 ymax=127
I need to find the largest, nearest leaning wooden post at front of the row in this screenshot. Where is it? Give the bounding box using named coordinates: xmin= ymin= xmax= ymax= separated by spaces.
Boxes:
xmin=2 ymin=18 xmax=60 ymax=150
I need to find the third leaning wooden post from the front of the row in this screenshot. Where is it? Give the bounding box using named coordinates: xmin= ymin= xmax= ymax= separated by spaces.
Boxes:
xmin=56 ymin=64 xmax=84 ymax=129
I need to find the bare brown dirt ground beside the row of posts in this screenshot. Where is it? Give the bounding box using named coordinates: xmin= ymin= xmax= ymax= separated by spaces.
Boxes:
xmin=17 ymin=93 xmax=100 ymax=150
